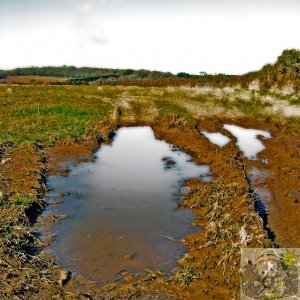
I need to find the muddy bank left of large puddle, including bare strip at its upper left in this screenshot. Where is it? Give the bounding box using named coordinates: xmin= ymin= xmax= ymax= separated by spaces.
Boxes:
xmin=0 ymin=124 xmax=112 ymax=299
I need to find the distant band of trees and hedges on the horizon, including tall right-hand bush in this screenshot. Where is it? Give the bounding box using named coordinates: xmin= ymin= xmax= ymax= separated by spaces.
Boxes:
xmin=0 ymin=49 xmax=300 ymax=90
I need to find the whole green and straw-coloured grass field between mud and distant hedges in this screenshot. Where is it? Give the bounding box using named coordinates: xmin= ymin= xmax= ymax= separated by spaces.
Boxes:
xmin=0 ymin=85 xmax=300 ymax=144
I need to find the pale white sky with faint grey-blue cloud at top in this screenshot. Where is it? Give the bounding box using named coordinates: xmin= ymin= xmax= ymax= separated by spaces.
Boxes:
xmin=0 ymin=0 xmax=300 ymax=74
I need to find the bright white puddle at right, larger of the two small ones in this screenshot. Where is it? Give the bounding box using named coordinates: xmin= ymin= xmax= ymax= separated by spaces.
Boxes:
xmin=224 ymin=124 xmax=271 ymax=159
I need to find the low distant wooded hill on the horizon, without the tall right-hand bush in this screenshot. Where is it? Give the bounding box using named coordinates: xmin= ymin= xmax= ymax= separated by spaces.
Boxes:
xmin=0 ymin=66 xmax=233 ymax=86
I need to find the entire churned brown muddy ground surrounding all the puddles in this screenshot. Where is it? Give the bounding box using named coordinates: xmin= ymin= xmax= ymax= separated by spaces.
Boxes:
xmin=0 ymin=117 xmax=300 ymax=299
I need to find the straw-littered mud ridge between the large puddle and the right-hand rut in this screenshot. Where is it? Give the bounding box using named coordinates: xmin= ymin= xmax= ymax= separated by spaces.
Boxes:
xmin=154 ymin=120 xmax=270 ymax=299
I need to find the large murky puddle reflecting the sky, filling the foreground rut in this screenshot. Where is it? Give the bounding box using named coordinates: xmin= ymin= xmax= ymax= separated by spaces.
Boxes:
xmin=39 ymin=127 xmax=211 ymax=283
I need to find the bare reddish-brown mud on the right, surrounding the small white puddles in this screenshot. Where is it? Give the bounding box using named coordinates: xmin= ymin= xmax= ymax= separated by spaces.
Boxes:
xmin=200 ymin=118 xmax=300 ymax=248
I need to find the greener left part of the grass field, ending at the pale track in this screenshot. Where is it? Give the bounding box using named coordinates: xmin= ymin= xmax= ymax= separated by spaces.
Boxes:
xmin=0 ymin=86 xmax=114 ymax=143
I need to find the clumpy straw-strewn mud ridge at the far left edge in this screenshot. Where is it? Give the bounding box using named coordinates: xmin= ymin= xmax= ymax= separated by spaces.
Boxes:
xmin=0 ymin=144 xmax=68 ymax=299
